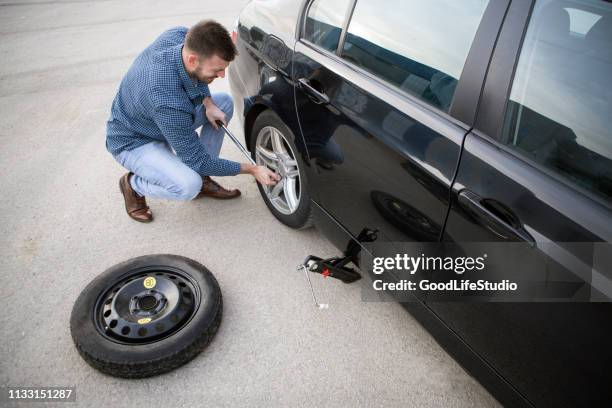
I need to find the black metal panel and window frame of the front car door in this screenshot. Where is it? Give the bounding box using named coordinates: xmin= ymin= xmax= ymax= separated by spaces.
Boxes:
xmin=428 ymin=1 xmax=612 ymax=407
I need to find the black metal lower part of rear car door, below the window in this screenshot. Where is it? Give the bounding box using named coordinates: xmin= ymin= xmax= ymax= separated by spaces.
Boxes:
xmin=293 ymin=42 xmax=467 ymax=300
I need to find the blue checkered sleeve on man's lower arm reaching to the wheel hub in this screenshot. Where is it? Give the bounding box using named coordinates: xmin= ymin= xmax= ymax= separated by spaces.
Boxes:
xmin=153 ymin=106 xmax=240 ymax=176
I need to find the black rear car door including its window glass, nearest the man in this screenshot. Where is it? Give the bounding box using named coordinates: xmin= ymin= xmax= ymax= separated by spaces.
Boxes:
xmin=292 ymin=0 xmax=507 ymax=286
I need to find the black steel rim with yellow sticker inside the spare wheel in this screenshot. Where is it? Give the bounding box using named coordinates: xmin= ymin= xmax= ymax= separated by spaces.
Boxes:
xmin=93 ymin=266 xmax=202 ymax=345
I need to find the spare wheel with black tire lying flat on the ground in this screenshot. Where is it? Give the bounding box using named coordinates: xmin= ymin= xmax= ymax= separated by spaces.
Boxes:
xmin=70 ymin=255 xmax=223 ymax=378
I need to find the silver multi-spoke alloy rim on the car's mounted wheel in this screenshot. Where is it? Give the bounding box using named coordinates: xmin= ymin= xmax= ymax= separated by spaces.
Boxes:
xmin=255 ymin=126 xmax=302 ymax=215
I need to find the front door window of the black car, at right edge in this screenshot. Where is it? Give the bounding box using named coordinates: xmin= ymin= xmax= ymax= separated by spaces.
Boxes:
xmin=502 ymin=1 xmax=612 ymax=202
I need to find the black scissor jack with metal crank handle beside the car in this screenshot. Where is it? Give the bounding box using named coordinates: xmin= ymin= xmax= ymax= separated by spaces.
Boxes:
xmin=297 ymin=228 xmax=378 ymax=309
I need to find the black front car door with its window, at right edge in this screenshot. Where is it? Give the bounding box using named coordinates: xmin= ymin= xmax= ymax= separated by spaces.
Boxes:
xmin=428 ymin=0 xmax=612 ymax=407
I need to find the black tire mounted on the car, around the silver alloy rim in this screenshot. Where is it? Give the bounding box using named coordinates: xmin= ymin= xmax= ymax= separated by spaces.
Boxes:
xmin=249 ymin=110 xmax=312 ymax=229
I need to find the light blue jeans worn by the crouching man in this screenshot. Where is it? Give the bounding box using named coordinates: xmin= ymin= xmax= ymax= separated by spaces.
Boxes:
xmin=115 ymin=93 xmax=234 ymax=200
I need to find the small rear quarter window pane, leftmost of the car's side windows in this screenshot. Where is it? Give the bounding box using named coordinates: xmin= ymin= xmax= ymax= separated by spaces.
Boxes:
xmin=304 ymin=0 xmax=350 ymax=52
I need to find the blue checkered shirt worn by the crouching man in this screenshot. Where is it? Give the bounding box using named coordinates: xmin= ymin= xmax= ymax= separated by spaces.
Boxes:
xmin=106 ymin=27 xmax=240 ymax=176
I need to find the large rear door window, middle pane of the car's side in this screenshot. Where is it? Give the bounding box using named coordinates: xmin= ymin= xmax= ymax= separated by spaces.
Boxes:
xmin=342 ymin=0 xmax=488 ymax=111
